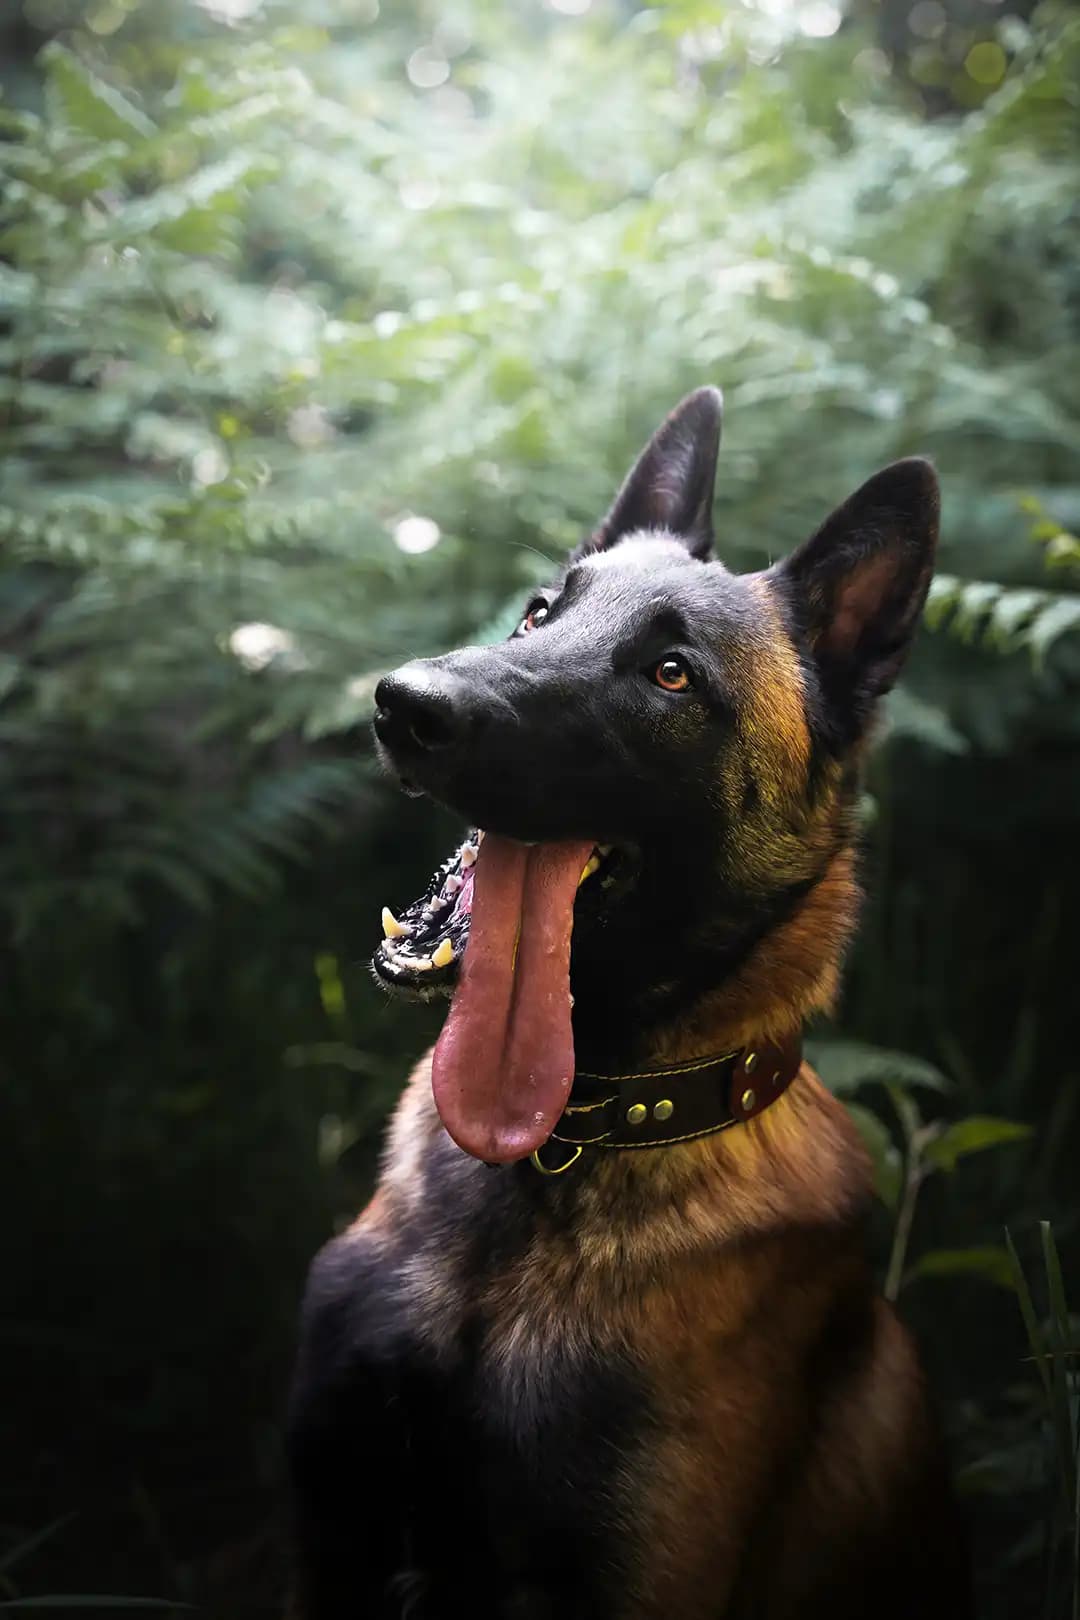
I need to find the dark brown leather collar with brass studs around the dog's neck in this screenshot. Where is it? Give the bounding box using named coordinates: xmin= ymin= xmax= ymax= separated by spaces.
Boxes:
xmin=531 ymin=1032 xmax=803 ymax=1176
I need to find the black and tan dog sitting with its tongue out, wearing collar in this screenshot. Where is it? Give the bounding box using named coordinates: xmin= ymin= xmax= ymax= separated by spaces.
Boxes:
xmin=291 ymin=389 xmax=970 ymax=1620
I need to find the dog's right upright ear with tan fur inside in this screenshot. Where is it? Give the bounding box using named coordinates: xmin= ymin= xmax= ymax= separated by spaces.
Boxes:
xmin=769 ymin=458 xmax=939 ymax=727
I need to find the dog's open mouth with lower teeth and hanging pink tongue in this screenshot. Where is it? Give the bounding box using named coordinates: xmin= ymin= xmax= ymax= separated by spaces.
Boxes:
xmin=372 ymin=833 xmax=619 ymax=1163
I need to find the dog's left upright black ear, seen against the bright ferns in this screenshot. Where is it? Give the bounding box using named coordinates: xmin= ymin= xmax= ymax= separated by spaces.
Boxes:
xmin=576 ymin=389 xmax=724 ymax=557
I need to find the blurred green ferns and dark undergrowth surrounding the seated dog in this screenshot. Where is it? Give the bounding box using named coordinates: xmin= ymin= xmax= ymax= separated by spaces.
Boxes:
xmin=0 ymin=0 xmax=1080 ymax=1620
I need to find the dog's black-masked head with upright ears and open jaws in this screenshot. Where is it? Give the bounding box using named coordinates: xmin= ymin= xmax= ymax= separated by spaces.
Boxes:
xmin=374 ymin=389 xmax=938 ymax=1158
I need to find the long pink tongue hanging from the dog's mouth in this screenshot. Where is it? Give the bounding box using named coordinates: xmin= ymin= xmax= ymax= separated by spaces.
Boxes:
xmin=431 ymin=833 xmax=593 ymax=1163
